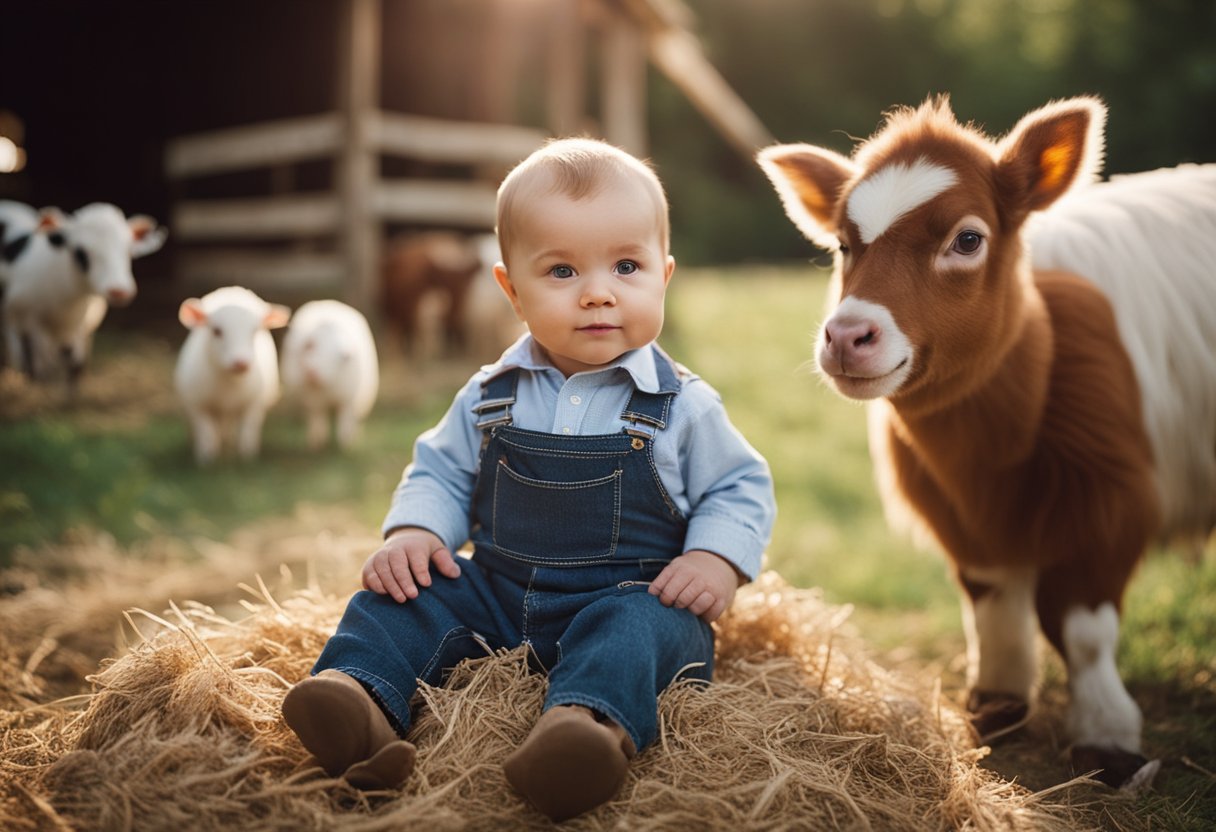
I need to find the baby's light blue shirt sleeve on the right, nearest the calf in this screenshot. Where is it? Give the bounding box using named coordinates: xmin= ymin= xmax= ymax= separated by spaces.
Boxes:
xmin=674 ymin=380 xmax=777 ymax=580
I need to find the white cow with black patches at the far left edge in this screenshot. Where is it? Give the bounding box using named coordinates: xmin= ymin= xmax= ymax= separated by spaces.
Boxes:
xmin=0 ymin=202 xmax=167 ymax=389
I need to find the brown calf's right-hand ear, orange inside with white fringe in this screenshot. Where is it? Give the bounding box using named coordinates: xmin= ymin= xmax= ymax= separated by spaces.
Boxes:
xmin=997 ymin=96 xmax=1107 ymax=215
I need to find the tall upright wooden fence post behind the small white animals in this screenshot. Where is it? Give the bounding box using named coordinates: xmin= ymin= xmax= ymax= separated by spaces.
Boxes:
xmin=337 ymin=0 xmax=381 ymax=319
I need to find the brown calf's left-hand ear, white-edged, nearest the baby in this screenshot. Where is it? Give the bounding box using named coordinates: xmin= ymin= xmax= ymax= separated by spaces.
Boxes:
xmin=756 ymin=145 xmax=858 ymax=249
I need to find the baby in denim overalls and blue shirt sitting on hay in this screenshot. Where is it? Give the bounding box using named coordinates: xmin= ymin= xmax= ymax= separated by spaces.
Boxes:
xmin=283 ymin=139 xmax=776 ymax=821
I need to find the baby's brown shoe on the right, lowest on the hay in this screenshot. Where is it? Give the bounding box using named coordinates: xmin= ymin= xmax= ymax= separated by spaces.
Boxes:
xmin=502 ymin=705 xmax=637 ymax=822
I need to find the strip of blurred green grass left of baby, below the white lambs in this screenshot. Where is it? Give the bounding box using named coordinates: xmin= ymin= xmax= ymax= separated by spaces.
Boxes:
xmin=0 ymin=414 xmax=437 ymax=547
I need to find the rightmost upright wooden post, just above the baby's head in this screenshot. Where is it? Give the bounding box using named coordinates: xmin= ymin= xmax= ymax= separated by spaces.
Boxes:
xmin=599 ymin=13 xmax=648 ymax=157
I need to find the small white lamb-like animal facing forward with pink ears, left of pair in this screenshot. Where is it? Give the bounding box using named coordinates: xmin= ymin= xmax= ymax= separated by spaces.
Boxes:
xmin=174 ymin=286 xmax=292 ymax=465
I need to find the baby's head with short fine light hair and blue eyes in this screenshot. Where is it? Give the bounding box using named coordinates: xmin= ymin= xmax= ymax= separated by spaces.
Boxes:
xmin=494 ymin=139 xmax=675 ymax=376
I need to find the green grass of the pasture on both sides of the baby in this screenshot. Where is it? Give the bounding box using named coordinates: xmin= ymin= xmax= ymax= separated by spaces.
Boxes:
xmin=0 ymin=265 xmax=1216 ymax=830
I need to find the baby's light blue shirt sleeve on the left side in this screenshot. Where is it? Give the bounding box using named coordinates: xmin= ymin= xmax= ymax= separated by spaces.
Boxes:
xmin=381 ymin=373 xmax=482 ymax=552
